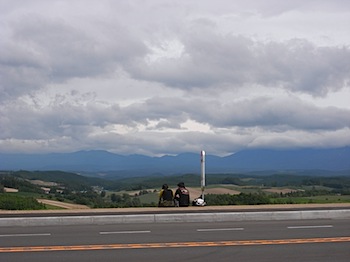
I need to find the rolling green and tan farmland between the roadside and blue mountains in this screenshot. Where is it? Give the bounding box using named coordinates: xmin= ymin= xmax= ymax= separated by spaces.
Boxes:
xmin=0 ymin=171 xmax=350 ymax=210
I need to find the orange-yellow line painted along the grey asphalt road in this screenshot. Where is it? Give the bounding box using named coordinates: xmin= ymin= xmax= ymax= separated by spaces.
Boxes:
xmin=0 ymin=237 xmax=350 ymax=253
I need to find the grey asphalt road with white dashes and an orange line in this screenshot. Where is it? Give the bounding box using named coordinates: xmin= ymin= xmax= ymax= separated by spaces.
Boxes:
xmin=0 ymin=219 xmax=350 ymax=262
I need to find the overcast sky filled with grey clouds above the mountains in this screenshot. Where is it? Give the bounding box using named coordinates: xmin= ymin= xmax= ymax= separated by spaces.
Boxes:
xmin=0 ymin=0 xmax=350 ymax=156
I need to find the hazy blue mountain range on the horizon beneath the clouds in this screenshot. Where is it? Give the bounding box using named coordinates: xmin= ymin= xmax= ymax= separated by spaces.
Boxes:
xmin=0 ymin=147 xmax=350 ymax=176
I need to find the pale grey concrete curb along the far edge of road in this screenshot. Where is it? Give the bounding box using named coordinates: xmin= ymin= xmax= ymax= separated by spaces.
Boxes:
xmin=0 ymin=209 xmax=350 ymax=227
